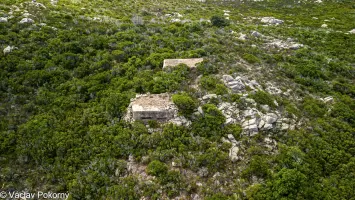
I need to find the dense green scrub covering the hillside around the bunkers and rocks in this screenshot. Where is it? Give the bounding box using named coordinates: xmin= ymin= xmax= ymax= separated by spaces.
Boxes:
xmin=0 ymin=0 xmax=355 ymax=199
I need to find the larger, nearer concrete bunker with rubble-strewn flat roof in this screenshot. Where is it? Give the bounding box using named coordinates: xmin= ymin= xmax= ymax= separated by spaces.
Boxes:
xmin=126 ymin=94 xmax=177 ymax=122
